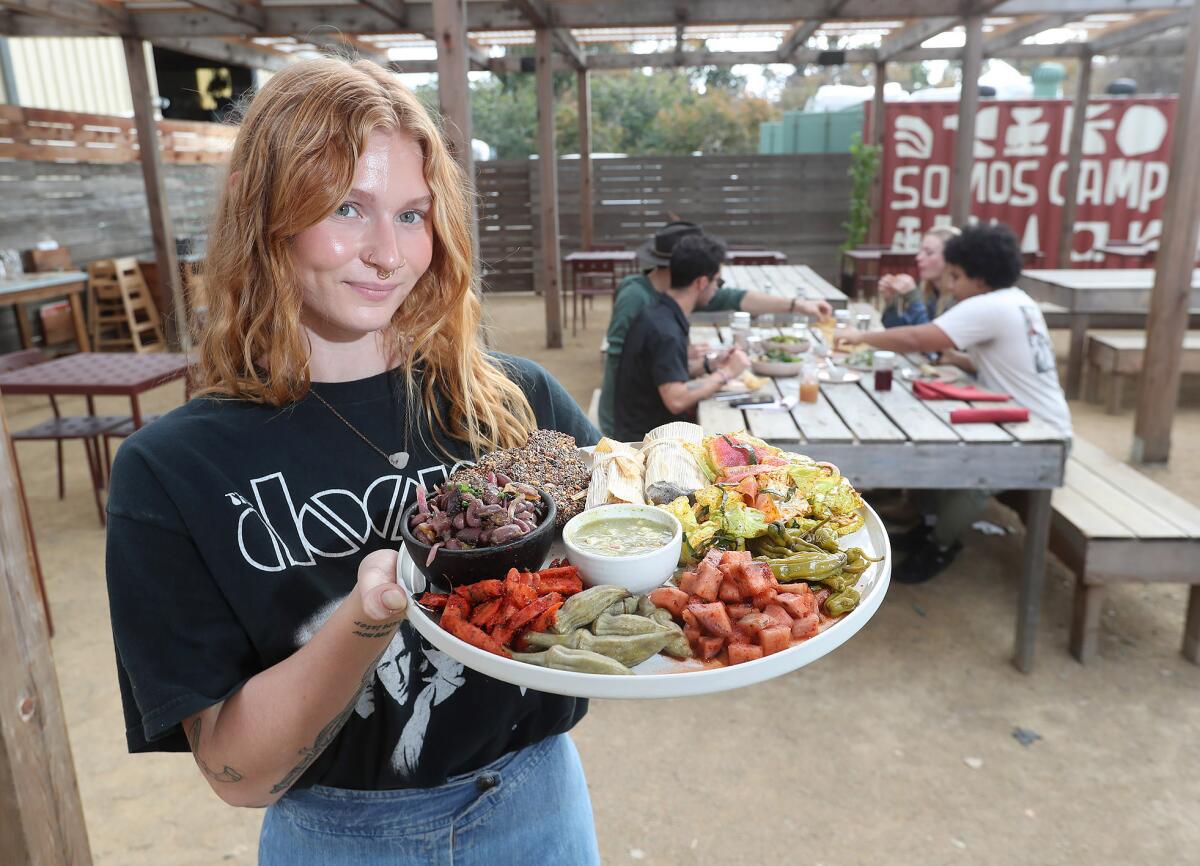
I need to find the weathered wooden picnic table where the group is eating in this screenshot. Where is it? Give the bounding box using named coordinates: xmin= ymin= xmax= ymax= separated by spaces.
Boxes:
xmin=691 ymin=326 xmax=1067 ymax=672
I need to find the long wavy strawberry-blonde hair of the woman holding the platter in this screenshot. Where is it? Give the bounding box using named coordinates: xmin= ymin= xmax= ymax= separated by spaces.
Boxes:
xmin=196 ymin=58 xmax=536 ymax=456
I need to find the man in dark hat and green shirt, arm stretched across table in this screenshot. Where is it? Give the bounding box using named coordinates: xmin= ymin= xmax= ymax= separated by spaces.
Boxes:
xmin=599 ymin=221 xmax=833 ymax=435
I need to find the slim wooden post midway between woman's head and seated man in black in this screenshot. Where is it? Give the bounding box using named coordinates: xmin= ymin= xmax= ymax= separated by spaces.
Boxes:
xmin=534 ymin=28 xmax=563 ymax=349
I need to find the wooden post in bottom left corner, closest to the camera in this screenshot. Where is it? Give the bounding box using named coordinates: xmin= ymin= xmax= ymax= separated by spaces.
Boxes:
xmin=0 ymin=405 xmax=91 ymax=866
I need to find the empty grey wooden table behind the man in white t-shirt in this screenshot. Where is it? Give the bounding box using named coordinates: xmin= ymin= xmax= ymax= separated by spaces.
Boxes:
xmin=1016 ymin=267 xmax=1200 ymax=399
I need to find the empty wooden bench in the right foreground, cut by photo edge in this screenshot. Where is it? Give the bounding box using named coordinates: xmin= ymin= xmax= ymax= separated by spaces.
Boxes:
xmin=1050 ymin=439 xmax=1200 ymax=664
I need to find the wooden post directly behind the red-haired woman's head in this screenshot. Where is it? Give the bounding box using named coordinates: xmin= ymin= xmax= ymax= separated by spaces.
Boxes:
xmin=433 ymin=0 xmax=479 ymax=263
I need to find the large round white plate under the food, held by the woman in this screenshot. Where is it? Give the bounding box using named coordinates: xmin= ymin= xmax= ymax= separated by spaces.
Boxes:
xmin=396 ymin=505 xmax=892 ymax=699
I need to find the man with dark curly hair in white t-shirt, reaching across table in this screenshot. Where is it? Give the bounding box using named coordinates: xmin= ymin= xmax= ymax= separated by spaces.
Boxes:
xmin=840 ymin=220 xmax=1072 ymax=583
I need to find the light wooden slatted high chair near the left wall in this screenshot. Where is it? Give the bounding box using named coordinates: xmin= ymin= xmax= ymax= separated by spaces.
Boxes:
xmin=88 ymin=258 xmax=167 ymax=353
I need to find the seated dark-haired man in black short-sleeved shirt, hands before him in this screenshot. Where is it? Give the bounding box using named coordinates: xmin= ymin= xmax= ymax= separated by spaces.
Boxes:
xmin=614 ymin=234 xmax=750 ymax=441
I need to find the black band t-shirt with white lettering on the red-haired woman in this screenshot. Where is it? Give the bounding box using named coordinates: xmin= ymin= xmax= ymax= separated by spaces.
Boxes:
xmin=107 ymin=356 xmax=599 ymax=789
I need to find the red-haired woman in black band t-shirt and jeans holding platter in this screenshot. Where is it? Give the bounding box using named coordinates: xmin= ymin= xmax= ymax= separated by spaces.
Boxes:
xmin=107 ymin=59 xmax=599 ymax=866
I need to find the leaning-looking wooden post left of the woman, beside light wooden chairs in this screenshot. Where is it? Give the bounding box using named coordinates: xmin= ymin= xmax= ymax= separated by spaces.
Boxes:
xmin=121 ymin=36 xmax=184 ymax=351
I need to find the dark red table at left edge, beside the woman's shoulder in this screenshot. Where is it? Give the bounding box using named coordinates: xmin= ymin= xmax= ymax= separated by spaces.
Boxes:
xmin=0 ymin=351 xmax=188 ymax=429
